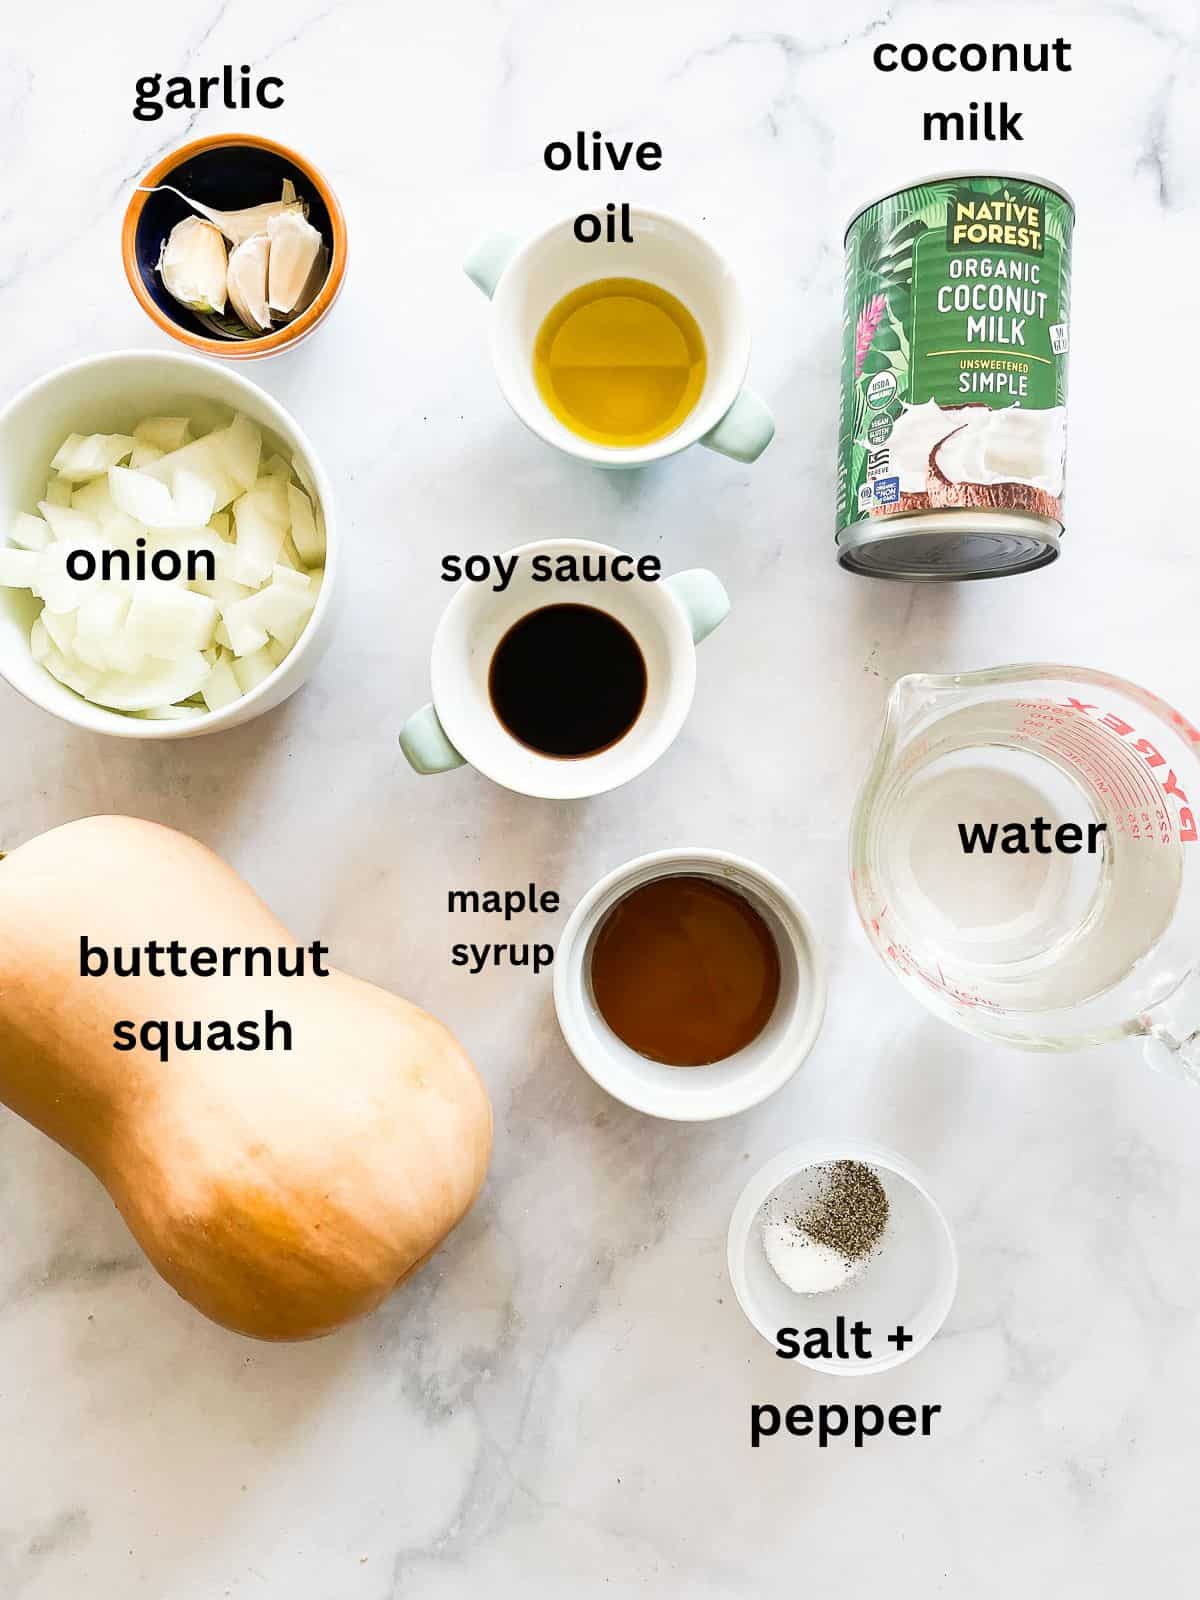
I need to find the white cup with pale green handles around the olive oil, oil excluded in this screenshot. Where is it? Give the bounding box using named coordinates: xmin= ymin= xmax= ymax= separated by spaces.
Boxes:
xmin=464 ymin=206 xmax=774 ymax=467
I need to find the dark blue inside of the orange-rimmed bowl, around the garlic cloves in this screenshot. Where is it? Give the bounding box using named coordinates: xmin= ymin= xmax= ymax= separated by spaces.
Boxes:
xmin=134 ymin=144 xmax=333 ymax=339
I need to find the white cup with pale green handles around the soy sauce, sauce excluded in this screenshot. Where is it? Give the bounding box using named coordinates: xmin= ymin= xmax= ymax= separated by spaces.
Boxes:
xmin=400 ymin=539 xmax=730 ymax=800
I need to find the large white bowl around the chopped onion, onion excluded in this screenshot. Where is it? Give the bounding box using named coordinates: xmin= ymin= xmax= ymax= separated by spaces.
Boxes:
xmin=0 ymin=350 xmax=338 ymax=739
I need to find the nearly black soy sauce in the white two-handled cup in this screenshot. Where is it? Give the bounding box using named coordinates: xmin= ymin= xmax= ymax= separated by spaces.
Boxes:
xmin=488 ymin=605 xmax=646 ymax=758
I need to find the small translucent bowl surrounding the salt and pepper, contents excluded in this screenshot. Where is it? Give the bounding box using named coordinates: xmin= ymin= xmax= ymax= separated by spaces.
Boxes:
xmin=728 ymin=1139 xmax=958 ymax=1378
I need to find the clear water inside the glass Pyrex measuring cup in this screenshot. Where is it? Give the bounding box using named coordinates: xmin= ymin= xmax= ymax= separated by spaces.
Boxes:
xmin=872 ymin=699 xmax=1182 ymax=1011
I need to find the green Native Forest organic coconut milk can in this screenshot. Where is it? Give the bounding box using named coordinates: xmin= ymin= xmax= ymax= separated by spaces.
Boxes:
xmin=837 ymin=176 xmax=1075 ymax=579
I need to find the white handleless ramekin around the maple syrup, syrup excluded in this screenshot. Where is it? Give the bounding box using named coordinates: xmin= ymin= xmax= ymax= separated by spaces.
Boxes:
xmin=554 ymin=848 xmax=826 ymax=1122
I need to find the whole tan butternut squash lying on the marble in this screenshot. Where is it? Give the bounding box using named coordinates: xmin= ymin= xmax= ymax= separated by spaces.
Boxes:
xmin=0 ymin=816 xmax=491 ymax=1339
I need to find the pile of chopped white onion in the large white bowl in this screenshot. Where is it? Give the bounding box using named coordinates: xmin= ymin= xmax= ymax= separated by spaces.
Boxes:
xmin=0 ymin=406 xmax=325 ymax=720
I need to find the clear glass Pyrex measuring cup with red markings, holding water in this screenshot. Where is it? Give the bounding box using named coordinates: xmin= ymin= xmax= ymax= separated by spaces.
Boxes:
xmin=850 ymin=666 xmax=1200 ymax=1083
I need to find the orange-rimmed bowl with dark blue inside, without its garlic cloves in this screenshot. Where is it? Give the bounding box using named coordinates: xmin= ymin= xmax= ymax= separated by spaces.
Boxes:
xmin=122 ymin=133 xmax=346 ymax=362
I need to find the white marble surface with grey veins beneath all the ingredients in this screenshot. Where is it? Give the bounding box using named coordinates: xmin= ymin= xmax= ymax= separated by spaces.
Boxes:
xmin=0 ymin=0 xmax=1200 ymax=1600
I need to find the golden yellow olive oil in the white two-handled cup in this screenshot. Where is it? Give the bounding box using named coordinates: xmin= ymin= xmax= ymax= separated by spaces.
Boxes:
xmin=533 ymin=278 xmax=706 ymax=448
